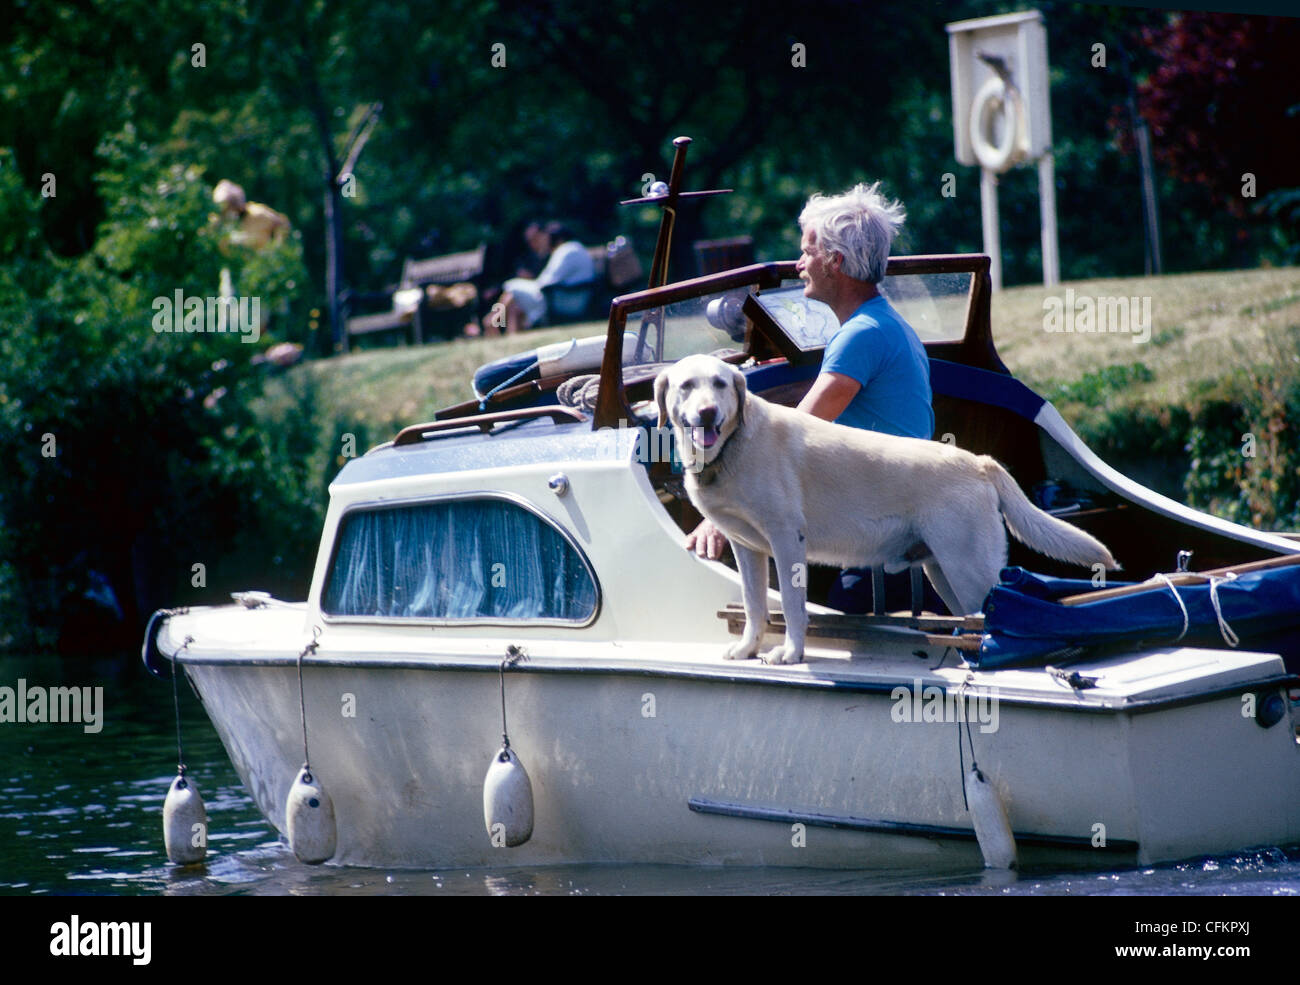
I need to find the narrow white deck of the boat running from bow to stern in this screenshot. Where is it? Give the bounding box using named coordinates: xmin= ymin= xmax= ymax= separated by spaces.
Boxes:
xmin=157 ymin=603 xmax=1300 ymax=712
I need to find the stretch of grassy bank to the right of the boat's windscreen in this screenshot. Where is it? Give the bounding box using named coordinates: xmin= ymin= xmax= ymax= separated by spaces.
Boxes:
xmin=993 ymin=268 xmax=1300 ymax=529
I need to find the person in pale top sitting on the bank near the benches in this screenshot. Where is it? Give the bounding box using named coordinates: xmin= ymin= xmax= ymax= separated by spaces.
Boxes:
xmin=485 ymin=222 xmax=595 ymax=335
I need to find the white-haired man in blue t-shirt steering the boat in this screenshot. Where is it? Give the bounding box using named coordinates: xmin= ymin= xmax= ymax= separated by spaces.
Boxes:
xmin=686 ymin=182 xmax=935 ymax=608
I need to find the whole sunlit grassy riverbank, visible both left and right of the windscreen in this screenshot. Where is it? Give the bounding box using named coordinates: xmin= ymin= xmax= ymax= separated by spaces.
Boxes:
xmin=257 ymin=268 xmax=1300 ymax=526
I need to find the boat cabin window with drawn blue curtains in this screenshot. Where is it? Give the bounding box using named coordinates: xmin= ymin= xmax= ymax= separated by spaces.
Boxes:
xmin=324 ymin=499 xmax=597 ymax=622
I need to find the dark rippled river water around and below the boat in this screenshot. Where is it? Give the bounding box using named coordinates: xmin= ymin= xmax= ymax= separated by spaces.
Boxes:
xmin=0 ymin=655 xmax=1300 ymax=895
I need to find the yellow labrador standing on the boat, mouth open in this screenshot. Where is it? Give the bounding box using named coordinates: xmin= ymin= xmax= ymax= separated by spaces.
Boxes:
xmin=654 ymin=356 xmax=1117 ymax=664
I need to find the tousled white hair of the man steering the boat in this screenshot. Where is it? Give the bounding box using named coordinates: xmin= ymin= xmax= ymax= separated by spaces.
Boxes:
xmin=800 ymin=182 xmax=907 ymax=283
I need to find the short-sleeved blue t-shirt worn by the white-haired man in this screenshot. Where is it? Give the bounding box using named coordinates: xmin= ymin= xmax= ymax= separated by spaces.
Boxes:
xmin=822 ymin=295 xmax=935 ymax=439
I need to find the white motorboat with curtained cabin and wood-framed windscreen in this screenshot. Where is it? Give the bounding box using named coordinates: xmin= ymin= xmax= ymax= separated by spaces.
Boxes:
xmin=144 ymin=245 xmax=1300 ymax=868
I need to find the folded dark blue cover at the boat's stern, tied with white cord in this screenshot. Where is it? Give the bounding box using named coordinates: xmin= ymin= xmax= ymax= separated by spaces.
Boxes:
xmin=967 ymin=565 xmax=1300 ymax=673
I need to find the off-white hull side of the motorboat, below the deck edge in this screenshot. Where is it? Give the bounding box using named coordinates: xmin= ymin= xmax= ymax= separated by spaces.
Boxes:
xmin=178 ymin=647 xmax=1300 ymax=868
